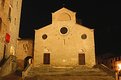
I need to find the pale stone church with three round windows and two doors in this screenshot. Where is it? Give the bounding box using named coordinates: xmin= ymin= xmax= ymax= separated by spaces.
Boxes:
xmin=33 ymin=8 xmax=96 ymax=67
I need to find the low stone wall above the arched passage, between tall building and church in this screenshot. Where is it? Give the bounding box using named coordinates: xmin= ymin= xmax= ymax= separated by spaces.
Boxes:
xmin=15 ymin=39 xmax=33 ymax=69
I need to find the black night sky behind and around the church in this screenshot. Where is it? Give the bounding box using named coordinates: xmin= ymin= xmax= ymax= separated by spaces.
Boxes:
xmin=20 ymin=0 xmax=121 ymax=54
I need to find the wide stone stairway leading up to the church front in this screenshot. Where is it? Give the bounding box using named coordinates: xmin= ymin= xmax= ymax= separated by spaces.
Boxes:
xmin=22 ymin=66 xmax=115 ymax=80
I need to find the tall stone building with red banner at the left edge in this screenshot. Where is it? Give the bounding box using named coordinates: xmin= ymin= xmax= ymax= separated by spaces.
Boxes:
xmin=0 ymin=0 xmax=22 ymax=62
